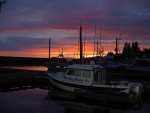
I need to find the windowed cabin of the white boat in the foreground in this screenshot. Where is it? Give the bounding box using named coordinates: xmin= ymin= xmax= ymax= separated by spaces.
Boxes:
xmin=64 ymin=65 xmax=107 ymax=85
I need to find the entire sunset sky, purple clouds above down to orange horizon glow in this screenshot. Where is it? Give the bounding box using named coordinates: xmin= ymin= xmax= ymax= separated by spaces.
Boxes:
xmin=0 ymin=0 xmax=150 ymax=58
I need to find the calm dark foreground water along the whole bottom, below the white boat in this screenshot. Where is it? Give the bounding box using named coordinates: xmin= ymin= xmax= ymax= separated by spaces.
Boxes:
xmin=0 ymin=88 xmax=150 ymax=113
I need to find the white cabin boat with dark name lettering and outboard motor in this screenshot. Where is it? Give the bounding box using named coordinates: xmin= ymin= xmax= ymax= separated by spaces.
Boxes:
xmin=47 ymin=61 xmax=143 ymax=101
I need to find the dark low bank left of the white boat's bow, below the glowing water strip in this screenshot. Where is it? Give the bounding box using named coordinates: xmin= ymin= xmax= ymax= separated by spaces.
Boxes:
xmin=0 ymin=68 xmax=50 ymax=91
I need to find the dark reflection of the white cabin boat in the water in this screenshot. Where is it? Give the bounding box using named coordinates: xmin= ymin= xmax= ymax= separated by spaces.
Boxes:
xmin=46 ymin=90 xmax=141 ymax=113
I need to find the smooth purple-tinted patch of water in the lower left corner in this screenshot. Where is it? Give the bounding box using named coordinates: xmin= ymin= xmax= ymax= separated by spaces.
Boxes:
xmin=0 ymin=89 xmax=64 ymax=113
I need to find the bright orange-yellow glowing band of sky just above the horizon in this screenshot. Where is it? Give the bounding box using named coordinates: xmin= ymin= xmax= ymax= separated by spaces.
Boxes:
xmin=0 ymin=38 xmax=149 ymax=58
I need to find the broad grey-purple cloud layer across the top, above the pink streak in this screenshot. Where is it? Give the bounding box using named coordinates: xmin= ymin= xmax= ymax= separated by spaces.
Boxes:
xmin=2 ymin=0 xmax=150 ymax=27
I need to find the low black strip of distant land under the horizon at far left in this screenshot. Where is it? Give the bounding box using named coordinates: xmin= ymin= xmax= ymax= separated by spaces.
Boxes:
xmin=0 ymin=56 xmax=48 ymax=66
